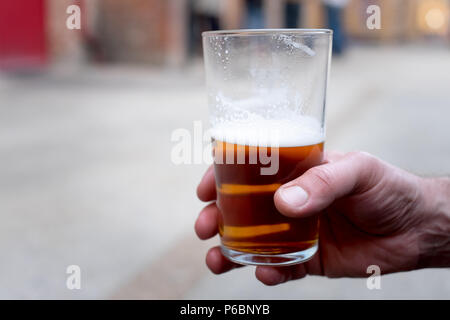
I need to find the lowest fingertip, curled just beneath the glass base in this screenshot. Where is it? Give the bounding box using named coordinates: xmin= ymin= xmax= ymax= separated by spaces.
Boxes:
xmin=255 ymin=264 xmax=306 ymax=286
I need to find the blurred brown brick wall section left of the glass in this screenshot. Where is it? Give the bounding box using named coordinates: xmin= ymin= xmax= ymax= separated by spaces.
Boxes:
xmin=96 ymin=0 xmax=187 ymax=64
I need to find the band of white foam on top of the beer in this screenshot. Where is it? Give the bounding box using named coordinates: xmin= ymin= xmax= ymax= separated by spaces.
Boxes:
xmin=211 ymin=116 xmax=325 ymax=147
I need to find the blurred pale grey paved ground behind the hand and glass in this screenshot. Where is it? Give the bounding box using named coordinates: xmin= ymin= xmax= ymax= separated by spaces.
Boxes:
xmin=0 ymin=46 xmax=450 ymax=299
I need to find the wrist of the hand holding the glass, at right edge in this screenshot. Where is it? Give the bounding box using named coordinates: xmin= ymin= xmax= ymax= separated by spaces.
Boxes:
xmin=418 ymin=178 xmax=450 ymax=268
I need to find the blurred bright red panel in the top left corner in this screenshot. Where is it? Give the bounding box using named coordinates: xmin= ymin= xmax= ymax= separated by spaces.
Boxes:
xmin=0 ymin=0 xmax=45 ymax=67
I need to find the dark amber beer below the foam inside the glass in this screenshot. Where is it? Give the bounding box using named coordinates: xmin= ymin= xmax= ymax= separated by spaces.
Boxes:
xmin=213 ymin=126 xmax=324 ymax=263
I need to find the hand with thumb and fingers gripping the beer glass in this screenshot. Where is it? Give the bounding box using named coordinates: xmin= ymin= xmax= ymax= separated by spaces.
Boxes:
xmin=195 ymin=152 xmax=450 ymax=285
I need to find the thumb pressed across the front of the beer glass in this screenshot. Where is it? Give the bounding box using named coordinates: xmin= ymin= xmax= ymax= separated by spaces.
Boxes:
xmin=274 ymin=152 xmax=380 ymax=217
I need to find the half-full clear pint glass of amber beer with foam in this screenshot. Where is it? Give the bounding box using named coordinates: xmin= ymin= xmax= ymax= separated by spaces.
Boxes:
xmin=203 ymin=29 xmax=332 ymax=266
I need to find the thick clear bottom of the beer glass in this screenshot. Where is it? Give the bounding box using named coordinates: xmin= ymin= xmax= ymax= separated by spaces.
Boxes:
xmin=220 ymin=242 xmax=318 ymax=266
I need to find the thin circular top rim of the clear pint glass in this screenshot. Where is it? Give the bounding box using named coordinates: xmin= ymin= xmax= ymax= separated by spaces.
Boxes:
xmin=202 ymin=28 xmax=333 ymax=37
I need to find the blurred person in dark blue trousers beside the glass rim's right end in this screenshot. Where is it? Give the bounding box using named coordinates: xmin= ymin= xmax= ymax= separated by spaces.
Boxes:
xmin=322 ymin=0 xmax=348 ymax=55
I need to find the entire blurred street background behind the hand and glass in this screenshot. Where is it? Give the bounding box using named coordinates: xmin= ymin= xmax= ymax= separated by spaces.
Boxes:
xmin=0 ymin=0 xmax=450 ymax=299
